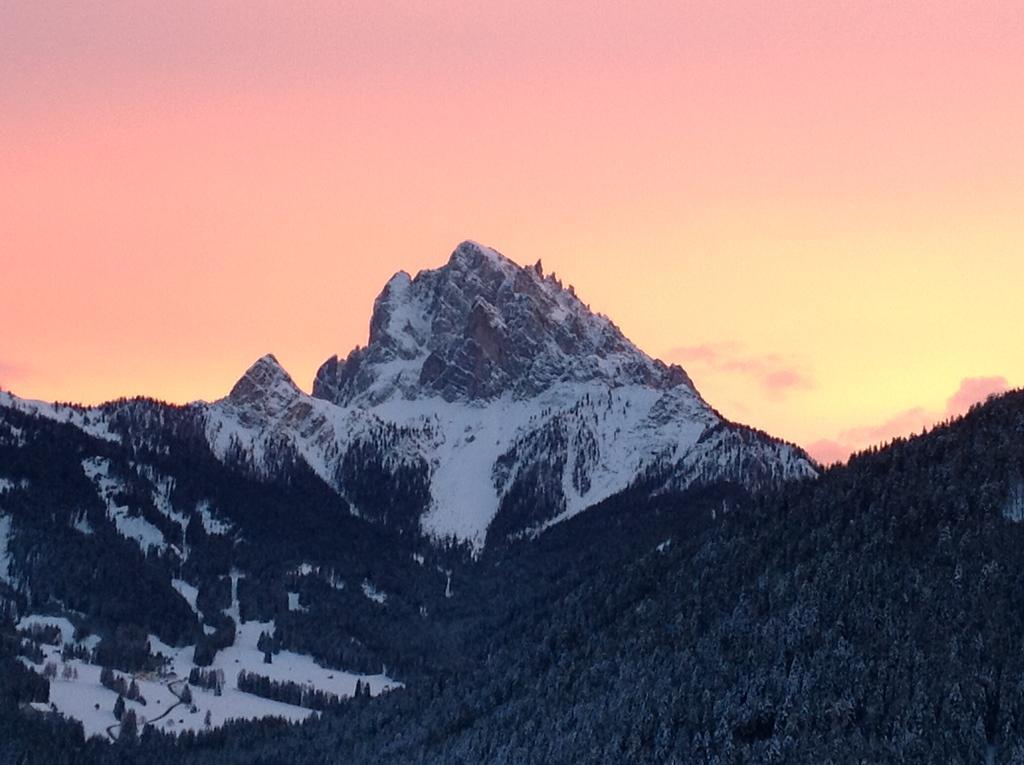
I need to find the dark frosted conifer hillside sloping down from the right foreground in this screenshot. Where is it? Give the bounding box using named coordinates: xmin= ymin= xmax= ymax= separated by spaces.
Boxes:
xmin=8 ymin=392 xmax=1024 ymax=764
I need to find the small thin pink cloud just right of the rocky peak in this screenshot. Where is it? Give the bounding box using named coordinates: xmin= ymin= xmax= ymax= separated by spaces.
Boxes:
xmin=666 ymin=343 xmax=814 ymax=398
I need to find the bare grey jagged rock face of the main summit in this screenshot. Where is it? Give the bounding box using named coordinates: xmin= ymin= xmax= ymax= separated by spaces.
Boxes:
xmin=313 ymin=242 xmax=692 ymax=406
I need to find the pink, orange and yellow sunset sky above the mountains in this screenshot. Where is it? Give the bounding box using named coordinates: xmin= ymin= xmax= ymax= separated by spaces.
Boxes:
xmin=0 ymin=0 xmax=1024 ymax=459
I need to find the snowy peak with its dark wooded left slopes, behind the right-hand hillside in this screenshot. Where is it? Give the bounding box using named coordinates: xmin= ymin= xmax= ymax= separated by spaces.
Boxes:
xmin=0 ymin=243 xmax=815 ymax=737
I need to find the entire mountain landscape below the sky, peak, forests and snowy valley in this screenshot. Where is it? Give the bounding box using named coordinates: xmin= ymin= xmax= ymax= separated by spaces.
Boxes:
xmin=0 ymin=242 xmax=1024 ymax=765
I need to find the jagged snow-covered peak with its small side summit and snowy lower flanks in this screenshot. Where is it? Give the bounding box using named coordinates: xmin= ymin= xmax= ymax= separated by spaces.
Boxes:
xmin=206 ymin=242 xmax=815 ymax=547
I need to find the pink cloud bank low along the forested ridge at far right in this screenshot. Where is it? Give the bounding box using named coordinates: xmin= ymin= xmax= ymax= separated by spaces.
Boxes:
xmin=806 ymin=377 xmax=1010 ymax=465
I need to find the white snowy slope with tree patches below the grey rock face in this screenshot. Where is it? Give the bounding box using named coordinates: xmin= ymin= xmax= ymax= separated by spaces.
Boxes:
xmin=208 ymin=358 xmax=729 ymax=545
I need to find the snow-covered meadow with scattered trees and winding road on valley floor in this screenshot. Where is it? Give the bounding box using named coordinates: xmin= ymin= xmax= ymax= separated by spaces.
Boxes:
xmin=17 ymin=578 xmax=401 ymax=737
